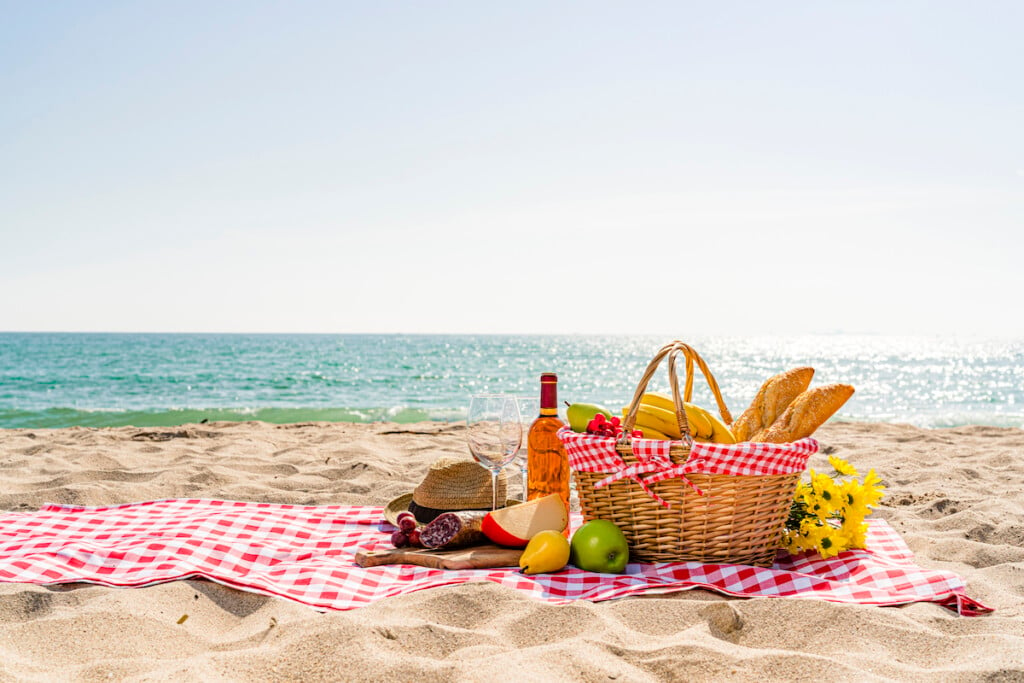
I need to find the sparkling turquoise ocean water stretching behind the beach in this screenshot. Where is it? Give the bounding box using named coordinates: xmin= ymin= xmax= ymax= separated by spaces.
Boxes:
xmin=0 ymin=333 xmax=1024 ymax=428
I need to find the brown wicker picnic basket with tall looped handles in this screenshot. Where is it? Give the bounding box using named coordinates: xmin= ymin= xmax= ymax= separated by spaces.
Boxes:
xmin=573 ymin=341 xmax=801 ymax=566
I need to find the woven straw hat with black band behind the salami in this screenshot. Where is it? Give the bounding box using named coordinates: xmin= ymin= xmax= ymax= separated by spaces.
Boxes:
xmin=384 ymin=456 xmax=513 ymax=524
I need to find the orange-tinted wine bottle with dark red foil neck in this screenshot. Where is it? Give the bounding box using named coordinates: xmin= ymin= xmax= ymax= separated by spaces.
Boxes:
xmin=526 ymin=373 xmax=569 ymax=537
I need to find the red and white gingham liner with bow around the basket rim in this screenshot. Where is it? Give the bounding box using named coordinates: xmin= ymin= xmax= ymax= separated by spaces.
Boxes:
xmin=558 ymin=427 xmax=818 ymax=508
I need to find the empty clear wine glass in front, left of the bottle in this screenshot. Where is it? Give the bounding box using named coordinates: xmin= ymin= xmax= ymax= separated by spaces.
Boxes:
xmin=466 ymin=393 xmax=522 ymax=510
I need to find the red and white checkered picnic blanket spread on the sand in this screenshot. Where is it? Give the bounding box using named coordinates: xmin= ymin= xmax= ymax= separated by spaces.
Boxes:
xmin=0 ymin=500 xmax=991 ymax=615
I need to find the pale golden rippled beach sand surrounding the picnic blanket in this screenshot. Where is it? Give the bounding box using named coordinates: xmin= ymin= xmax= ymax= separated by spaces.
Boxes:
xmin=0 ymin=423 xmax=1024 ymax=682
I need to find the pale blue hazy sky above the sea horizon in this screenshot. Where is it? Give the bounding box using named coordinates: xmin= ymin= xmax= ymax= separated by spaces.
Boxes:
xmin=0 ymin=0 xmax=1024 ymax=338
